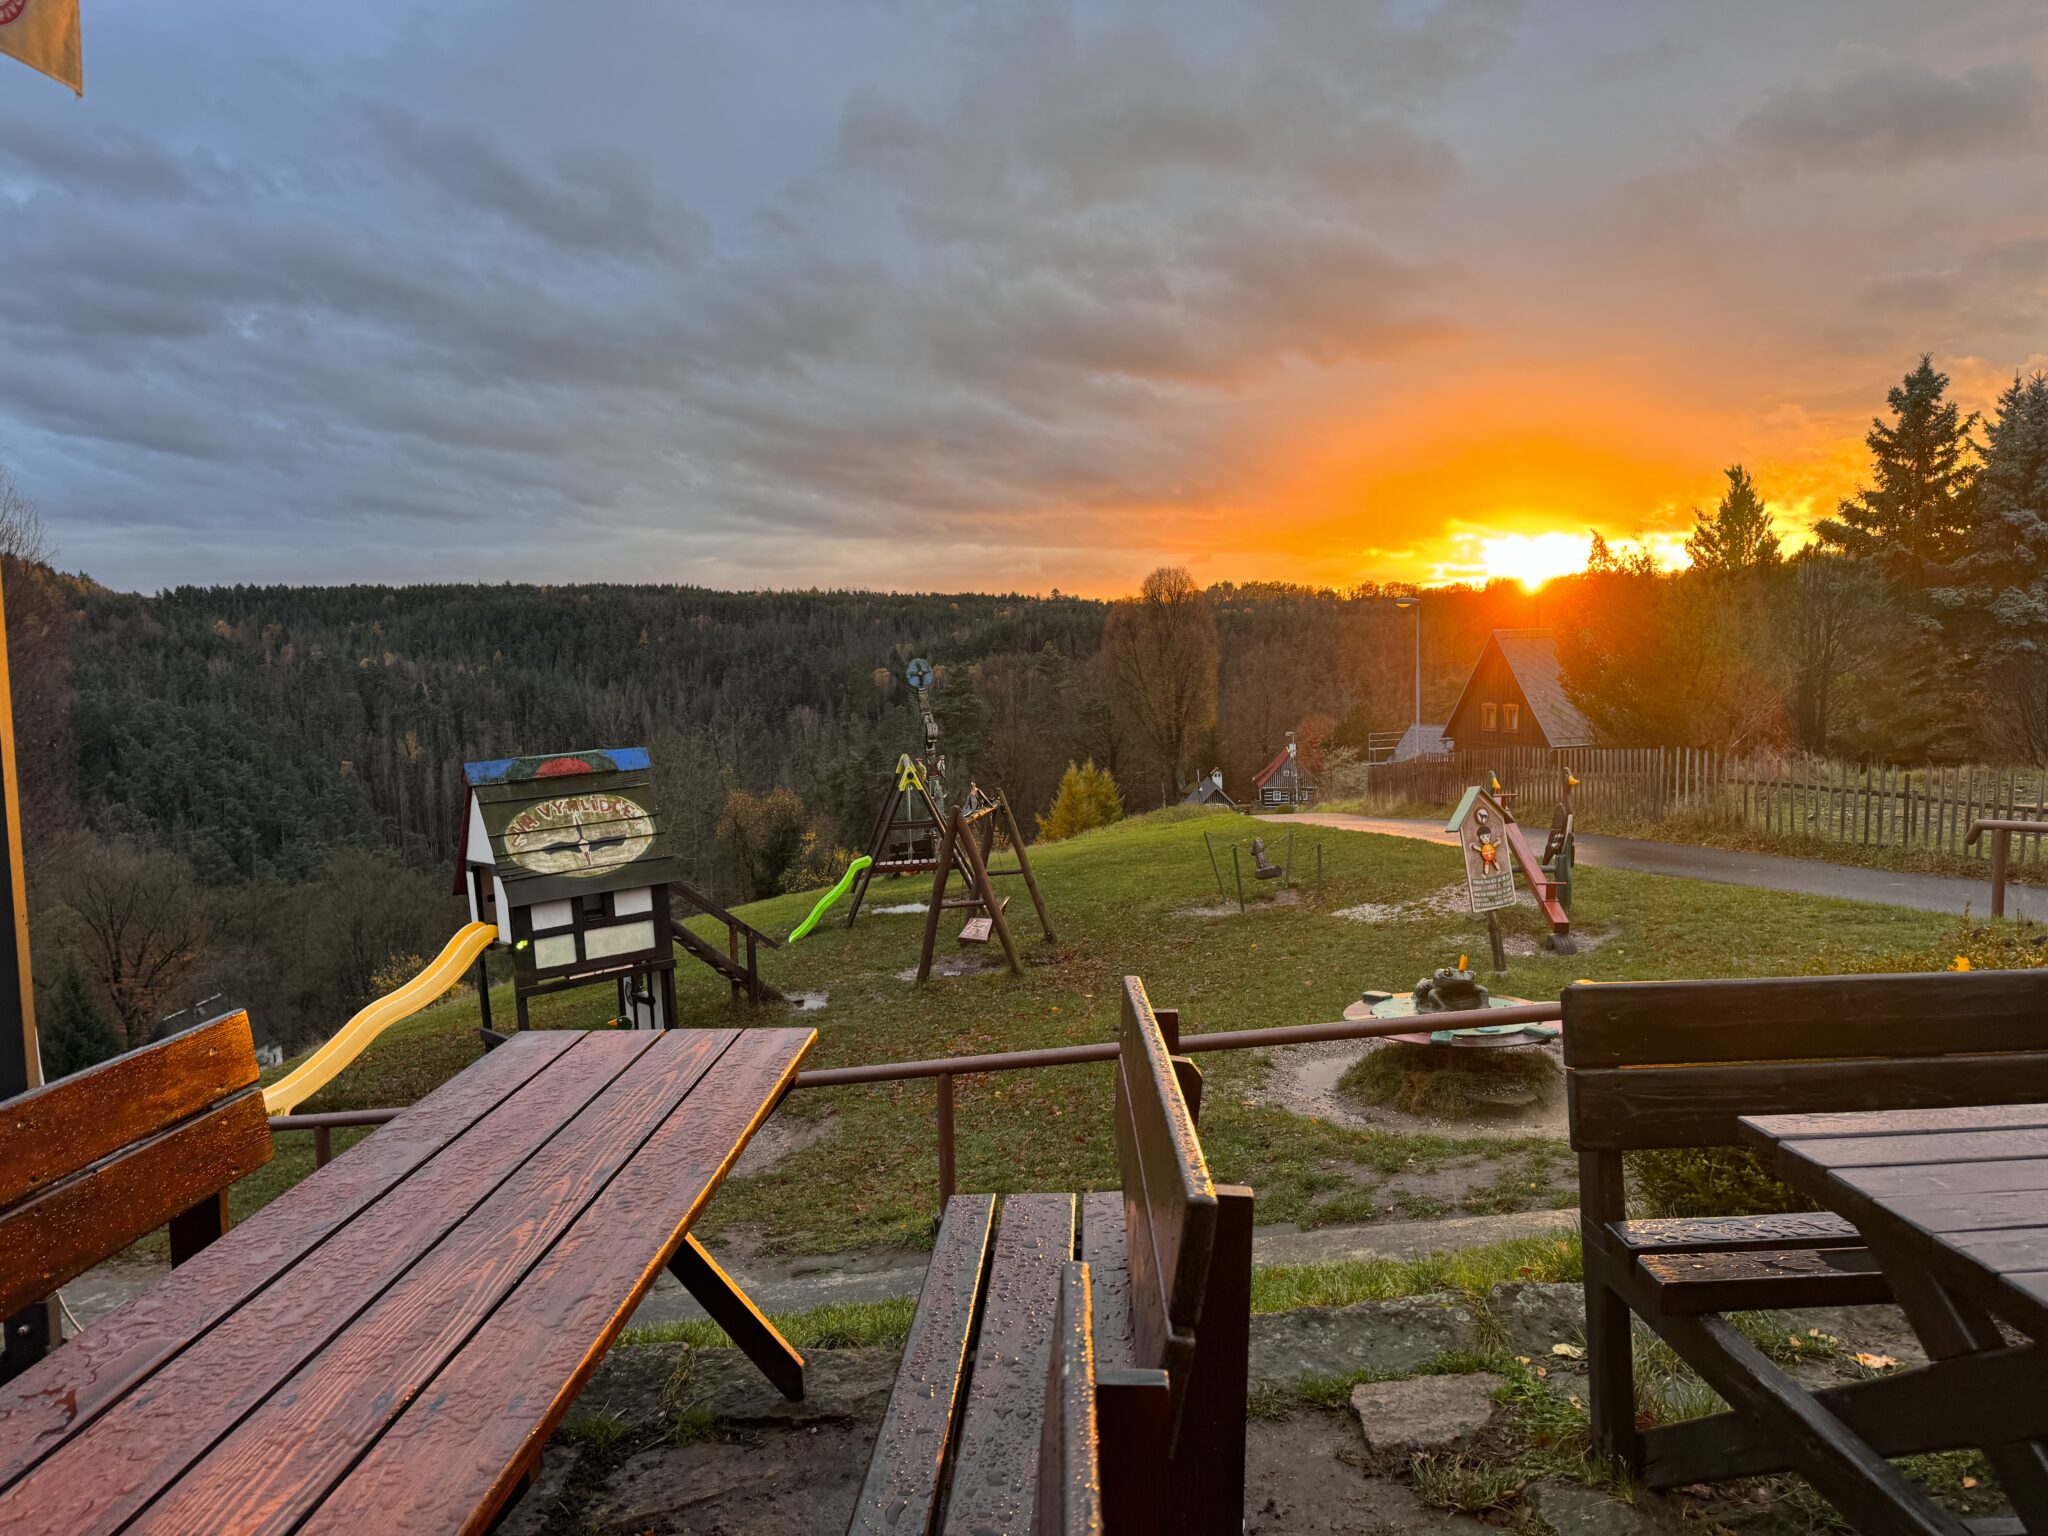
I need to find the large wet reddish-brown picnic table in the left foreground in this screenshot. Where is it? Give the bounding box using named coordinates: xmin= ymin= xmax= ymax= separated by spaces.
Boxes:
xmin=0 ymin=1028 xmax=815 ymax=1536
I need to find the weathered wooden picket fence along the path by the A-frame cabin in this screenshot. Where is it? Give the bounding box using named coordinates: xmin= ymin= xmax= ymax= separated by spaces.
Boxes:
xmin=1364 ymin=748 xmax=2048 ymax=862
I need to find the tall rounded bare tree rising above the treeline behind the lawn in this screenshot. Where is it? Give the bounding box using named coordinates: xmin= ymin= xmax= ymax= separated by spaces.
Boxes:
xmin=1102 ymin=565 xmax=1217 ymax=806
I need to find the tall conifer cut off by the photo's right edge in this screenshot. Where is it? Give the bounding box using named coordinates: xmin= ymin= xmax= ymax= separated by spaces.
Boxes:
xmin=1929 ymin=373 xmax=2048 ymax=762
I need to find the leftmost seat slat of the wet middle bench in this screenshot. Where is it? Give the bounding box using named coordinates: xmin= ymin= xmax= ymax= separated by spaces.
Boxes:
xmin=846 ymin=1194 xmax=995 ymax=1536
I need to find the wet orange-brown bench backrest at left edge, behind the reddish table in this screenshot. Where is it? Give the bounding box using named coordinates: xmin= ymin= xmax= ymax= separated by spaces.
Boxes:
xmin=0 ymin=1014 xmax=270 ymax=1317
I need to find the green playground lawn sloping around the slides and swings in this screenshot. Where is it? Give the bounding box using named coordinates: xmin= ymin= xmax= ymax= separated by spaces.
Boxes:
xmin=256 ymin=811 xmax=1954 ymax=1251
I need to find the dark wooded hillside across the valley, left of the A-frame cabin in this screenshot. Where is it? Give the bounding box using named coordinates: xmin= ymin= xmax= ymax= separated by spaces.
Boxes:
xmin=0 ymin=518 xmax=1532 ymax=1049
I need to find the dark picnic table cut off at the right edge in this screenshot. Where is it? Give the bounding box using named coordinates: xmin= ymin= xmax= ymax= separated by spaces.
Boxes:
xmin=1739 ymin=1104 xmax=2048 ymax=1534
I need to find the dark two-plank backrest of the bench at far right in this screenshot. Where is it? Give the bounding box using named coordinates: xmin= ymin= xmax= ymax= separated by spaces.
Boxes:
xmin=1563 ymin=971 xmax=2048 ymax=1153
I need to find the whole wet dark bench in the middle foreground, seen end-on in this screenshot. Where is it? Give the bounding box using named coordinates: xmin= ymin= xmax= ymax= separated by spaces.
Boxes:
xmin=848 ymin=977 xmax=1251 ymax=1536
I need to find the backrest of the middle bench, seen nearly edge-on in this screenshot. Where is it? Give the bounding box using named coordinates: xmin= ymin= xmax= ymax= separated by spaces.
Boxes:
xmin=1116 ymin=977 xmax=1217 ymax=1421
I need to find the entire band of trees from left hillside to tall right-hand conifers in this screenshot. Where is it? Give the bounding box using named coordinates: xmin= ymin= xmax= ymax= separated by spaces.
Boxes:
xmin=24 ymin=358 xmax=2048 ymax=1059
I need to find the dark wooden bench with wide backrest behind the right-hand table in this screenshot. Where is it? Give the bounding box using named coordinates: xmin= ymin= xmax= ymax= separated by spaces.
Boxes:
xmin=1563 ymin=971 xmax=2048 ymax=1487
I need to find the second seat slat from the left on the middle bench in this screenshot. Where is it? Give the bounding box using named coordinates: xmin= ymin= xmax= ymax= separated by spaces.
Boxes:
xmin=942 ymin=1194 xmax=1073 ymax=1536
